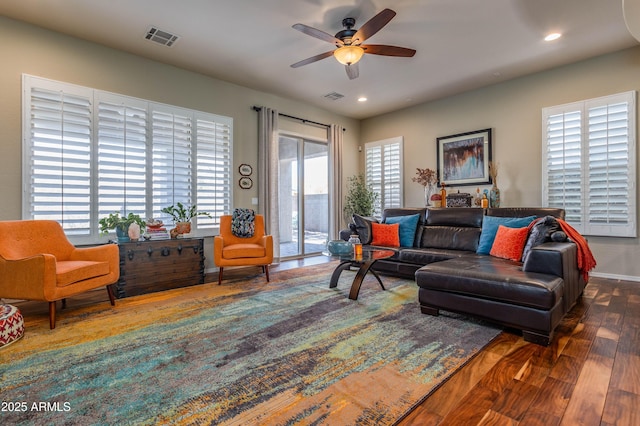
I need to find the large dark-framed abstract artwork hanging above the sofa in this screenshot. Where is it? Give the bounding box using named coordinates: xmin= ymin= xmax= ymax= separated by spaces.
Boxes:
xmin=437 ymin=129 xmax=491 ymax=186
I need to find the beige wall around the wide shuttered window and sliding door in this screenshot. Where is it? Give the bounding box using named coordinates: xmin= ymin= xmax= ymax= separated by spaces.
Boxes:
xmin=0 ymin=17 xmax=360 ymax=269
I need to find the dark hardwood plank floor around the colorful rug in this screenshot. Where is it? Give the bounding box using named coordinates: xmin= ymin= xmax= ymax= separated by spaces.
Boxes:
xmin=7 ymin=256 xmax=640 ymax=426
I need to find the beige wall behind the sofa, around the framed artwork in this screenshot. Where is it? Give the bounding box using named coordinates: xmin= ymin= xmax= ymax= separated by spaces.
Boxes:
xmin=361 ymin=47 xmax=640 ymax=280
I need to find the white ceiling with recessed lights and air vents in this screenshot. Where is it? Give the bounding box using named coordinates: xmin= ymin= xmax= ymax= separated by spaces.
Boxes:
xmin=0 ymin=0 xmax=638 ymax=118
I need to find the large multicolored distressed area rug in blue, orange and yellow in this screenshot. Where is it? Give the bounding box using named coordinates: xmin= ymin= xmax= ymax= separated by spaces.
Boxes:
xmin=0 ymin=264 xmax=500 ymax=425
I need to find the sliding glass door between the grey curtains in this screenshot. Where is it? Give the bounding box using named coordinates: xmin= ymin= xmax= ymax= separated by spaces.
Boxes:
xmin=279 ymin=136 xmax=329 ymax=258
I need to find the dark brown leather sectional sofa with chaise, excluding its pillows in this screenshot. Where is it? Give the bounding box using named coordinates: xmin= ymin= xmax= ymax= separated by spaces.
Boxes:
xmin=341 ymin=207 xmax=586 ymax=345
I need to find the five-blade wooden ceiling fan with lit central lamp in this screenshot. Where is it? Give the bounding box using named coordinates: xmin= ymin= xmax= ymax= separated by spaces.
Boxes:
xmin=291 ymin=9 xmax=416 ymax=80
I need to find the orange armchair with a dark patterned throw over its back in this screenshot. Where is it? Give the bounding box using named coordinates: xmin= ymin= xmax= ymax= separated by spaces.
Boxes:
xmin=213 ymin=214 xmax=273 ymax=284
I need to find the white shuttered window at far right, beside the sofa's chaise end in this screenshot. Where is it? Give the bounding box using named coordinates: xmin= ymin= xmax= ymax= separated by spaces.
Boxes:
xmin=542 ymin=92 xmax=637 ymax=237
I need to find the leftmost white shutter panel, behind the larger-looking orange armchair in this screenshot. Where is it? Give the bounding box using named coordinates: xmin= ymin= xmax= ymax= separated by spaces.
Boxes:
xmin=23 ymin=80 xmax=92 ymax=235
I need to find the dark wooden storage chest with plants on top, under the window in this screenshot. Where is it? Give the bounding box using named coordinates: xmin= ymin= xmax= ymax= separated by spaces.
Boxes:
xmin=115 ymin=238 xmax=204 ymax=298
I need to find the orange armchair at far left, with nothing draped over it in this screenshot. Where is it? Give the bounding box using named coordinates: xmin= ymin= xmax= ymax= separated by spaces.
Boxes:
xmin=0 ymin=220 xmax=120 ymax=329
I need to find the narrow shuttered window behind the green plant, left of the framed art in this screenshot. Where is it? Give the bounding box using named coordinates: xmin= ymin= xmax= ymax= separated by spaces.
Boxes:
xmin=365 ymin=137 xmax=403 ymax=216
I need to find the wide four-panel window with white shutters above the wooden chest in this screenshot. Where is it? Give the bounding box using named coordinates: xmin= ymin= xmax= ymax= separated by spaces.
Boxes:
xmin=23 ymin=75 xmax=233 ymax=243
